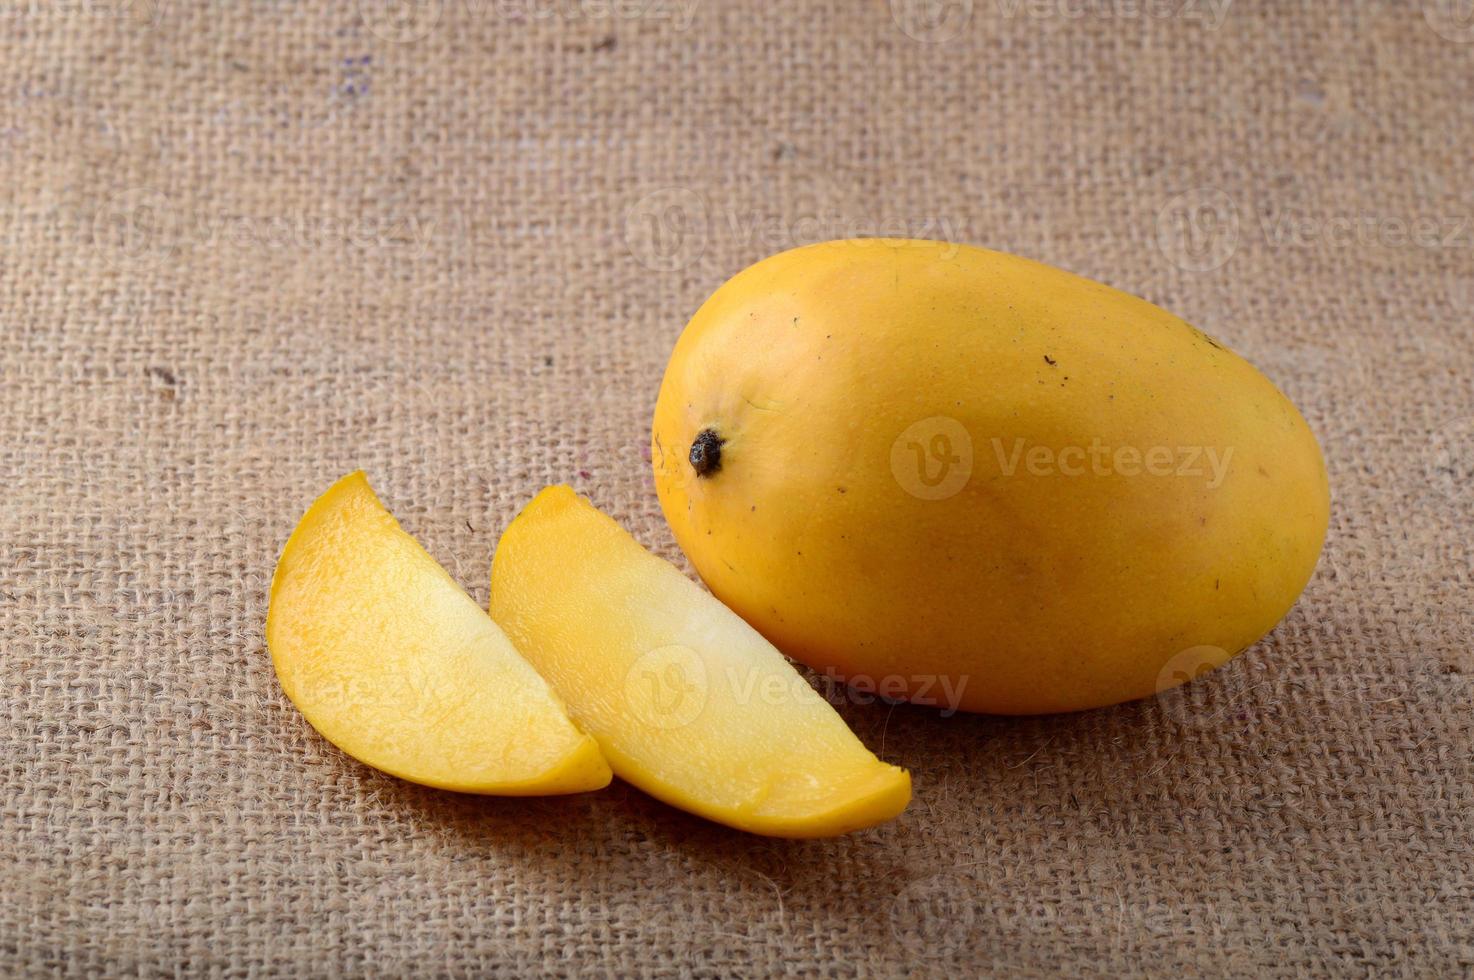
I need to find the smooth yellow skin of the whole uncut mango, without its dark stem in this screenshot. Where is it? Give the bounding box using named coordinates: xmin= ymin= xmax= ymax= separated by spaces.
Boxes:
xmin=652 ymin=239 xmax=1330 ymax=715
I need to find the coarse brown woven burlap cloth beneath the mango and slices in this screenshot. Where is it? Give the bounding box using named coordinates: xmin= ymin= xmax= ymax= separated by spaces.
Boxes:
xmin=0 ymin=0 xmax=1474 ymax=977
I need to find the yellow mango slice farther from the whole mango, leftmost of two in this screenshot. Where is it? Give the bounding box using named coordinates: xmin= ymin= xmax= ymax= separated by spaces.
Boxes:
xmin=267 ymin=473 xmax=612 ymax=796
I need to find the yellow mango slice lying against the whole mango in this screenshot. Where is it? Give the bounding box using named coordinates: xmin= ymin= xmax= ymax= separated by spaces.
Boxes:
xmin=491 ymin=486 xmax=911 ymax=837
